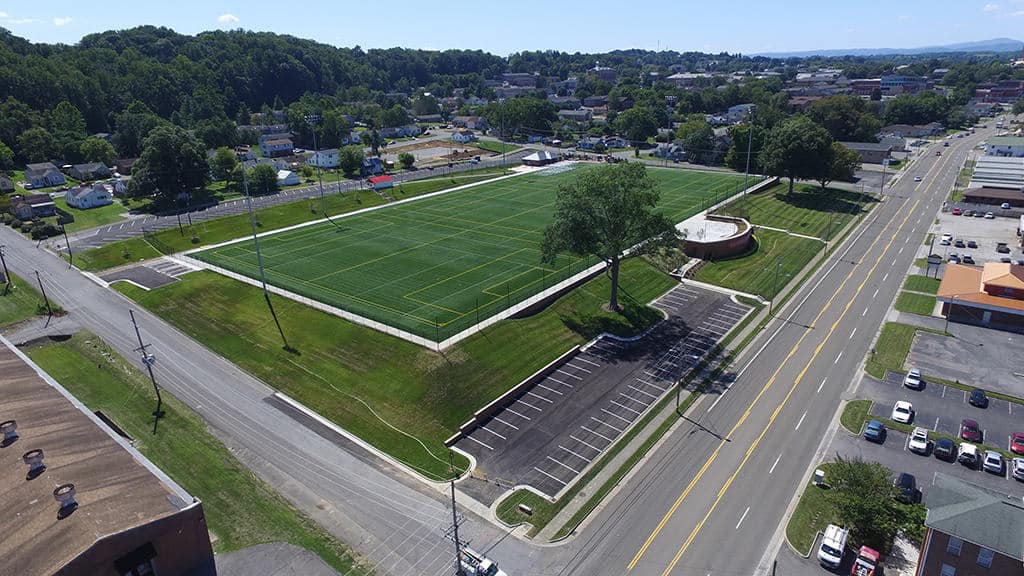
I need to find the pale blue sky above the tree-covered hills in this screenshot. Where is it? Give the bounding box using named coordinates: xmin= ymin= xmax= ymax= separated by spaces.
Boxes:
xmin=0 ymin=0 xmax=1024 ymax=55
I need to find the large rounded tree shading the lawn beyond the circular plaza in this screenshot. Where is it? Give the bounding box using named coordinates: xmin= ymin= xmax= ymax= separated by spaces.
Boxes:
xmin=758 ymin=116 xmax=833 ymax=193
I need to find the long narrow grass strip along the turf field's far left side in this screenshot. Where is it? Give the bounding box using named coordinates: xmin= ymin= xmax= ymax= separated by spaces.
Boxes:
xmin=74 ymin=172 xmax=503 ymax=271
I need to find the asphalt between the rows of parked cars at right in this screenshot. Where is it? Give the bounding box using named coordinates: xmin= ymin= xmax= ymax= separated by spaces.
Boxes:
xmin=859 ymin=372 xmax=1024 ymax=450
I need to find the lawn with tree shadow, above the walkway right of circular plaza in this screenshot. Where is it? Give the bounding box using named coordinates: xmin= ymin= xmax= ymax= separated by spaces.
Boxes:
xmin=721 ymin=181 xmax=873 ymax=239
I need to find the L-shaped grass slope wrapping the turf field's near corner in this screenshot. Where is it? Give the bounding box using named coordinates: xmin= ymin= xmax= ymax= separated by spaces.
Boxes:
xmin=117 ymin=258 xmax=675 ymax=479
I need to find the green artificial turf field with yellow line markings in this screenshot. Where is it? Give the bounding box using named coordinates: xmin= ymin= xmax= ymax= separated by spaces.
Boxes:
xmin=191 ymin=166 xmax=743 ymax=340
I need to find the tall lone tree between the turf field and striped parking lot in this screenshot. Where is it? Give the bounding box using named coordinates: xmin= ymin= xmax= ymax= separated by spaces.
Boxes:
xmin=541 ymin=162 xmax=678 ymax=311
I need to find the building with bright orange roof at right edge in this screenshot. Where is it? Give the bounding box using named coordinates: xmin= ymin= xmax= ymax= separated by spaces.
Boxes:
xmin=936 ymin=262 xmax=1024 ymax=332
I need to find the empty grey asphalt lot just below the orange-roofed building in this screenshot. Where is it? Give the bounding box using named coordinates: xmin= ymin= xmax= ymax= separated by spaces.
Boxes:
xmin=907 ymin=324 xmax=1024 ymax=398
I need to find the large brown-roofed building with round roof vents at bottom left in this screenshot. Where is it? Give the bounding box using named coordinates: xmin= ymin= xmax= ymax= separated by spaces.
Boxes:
xmin=0 ymin=337 xmax=216 ymax=576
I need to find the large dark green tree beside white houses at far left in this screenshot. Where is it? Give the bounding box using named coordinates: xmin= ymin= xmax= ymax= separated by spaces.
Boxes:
xmin=128 ymin=126 xmax=210 ymax=206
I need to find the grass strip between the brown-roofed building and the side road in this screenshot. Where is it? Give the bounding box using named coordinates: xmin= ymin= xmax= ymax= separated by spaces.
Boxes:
xmin=26 ymin=332 xmax=368 ymax=574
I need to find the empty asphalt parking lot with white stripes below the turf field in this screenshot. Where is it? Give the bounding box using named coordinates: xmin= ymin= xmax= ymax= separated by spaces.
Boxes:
xmin=455 ymin=284 xmax=751 ymax=497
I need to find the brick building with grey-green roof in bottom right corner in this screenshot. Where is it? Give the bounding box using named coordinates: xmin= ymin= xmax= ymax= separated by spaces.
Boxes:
xmin=916 ymin=471 xmax=1024 ymax=576
